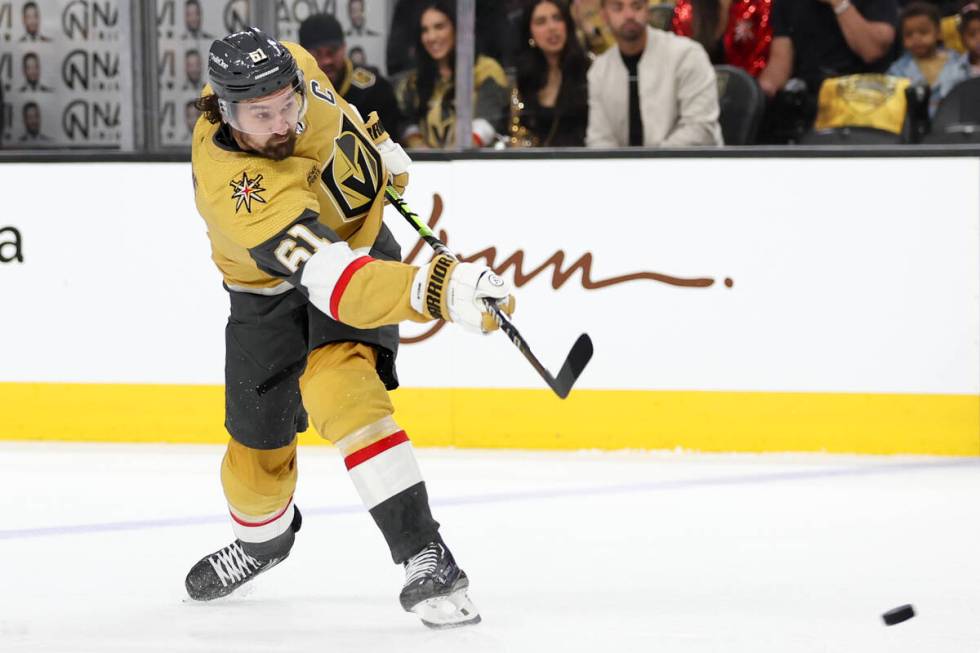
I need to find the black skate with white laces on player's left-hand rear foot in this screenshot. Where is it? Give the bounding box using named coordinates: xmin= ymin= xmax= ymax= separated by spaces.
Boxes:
xmin=184 ymin=508 xmax=303 ymax=601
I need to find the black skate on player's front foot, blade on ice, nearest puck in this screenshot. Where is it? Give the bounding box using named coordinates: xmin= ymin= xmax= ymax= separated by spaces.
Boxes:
xmin=399 ymin=542 xmax=480 ymax=628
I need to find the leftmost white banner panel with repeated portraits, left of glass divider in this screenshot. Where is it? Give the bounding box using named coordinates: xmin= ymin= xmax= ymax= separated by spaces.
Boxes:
xmin=0 ymin=0 xmax=133 ymax=150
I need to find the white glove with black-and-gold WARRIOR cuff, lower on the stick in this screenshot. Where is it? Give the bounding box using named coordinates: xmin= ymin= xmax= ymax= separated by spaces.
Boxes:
xmin=411 ymin=256 xmax=514 ymax=333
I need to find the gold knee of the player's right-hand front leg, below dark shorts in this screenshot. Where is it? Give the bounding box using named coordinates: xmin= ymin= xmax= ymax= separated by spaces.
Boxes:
xmin=300 ymin=342 xmax=394 ymax=443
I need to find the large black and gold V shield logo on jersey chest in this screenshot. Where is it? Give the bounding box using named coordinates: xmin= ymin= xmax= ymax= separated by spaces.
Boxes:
xmin=320 ymin=116 xmax=383 ymax=222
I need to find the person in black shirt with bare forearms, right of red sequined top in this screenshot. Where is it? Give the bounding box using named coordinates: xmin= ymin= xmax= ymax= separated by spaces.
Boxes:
xmin=759 ymin=0 xmax=898 ymax=99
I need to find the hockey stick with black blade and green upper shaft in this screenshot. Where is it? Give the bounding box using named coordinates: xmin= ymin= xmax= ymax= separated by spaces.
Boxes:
xmin=385 ymin=186 xmax=592 ymax=399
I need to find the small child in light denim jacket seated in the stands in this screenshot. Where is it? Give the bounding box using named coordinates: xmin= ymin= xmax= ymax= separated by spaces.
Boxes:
xmin=888 ymin=2 xmax=969 ymax=116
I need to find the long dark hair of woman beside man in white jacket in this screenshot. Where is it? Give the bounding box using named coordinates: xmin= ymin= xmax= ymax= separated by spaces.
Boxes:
xmin=517 ymin=0 xmax=589 ymax=108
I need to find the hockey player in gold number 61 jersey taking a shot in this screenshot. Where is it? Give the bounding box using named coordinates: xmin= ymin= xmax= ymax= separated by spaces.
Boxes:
xmin=186 ymin=28 xmax=512 ymax=628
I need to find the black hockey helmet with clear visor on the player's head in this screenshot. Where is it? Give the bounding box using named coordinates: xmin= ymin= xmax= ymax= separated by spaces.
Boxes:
xmin=208 ymin=27 xmax=306 ymax=134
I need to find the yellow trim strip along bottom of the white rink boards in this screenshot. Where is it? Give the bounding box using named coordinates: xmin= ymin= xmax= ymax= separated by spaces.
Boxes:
xmin=0 ymin=383 xmax=980 ymax=456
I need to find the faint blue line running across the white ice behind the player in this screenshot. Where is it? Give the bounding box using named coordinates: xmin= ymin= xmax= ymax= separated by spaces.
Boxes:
xmin=0 ymin=458 xmax=980 ymax=540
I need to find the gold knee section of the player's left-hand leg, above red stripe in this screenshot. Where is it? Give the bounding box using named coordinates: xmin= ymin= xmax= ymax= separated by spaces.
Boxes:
xmin=221 ymin=439 xmax=297 ymax=523
